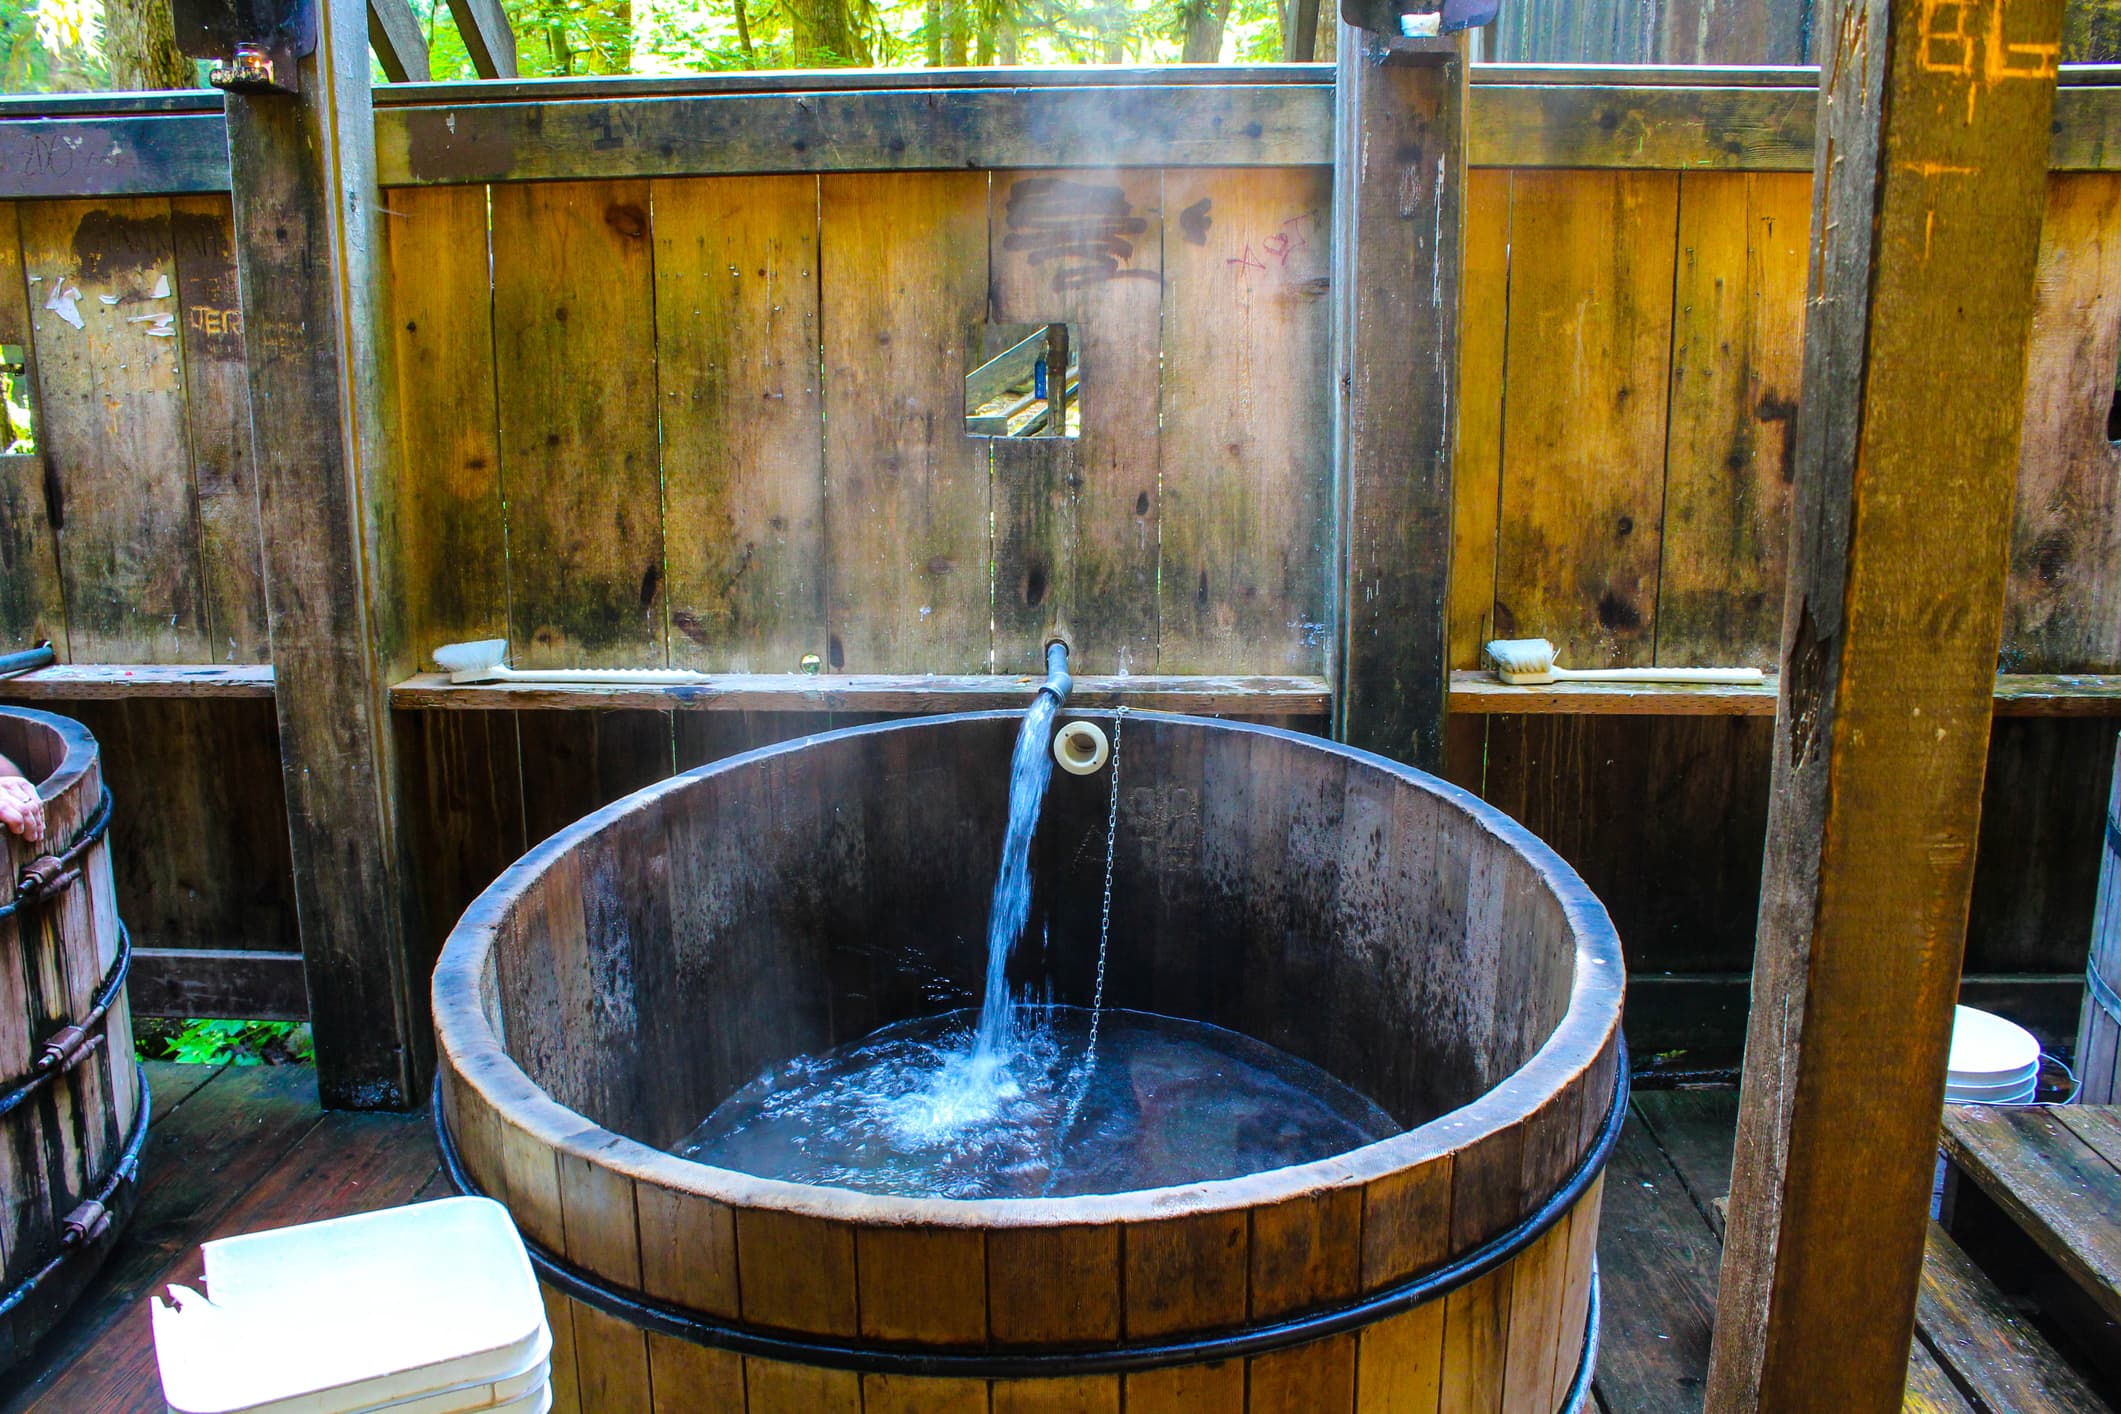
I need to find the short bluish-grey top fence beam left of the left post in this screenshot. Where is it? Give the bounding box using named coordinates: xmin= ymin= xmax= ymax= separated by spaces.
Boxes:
xmin=0 ymin=112 xmax=229 ymax=199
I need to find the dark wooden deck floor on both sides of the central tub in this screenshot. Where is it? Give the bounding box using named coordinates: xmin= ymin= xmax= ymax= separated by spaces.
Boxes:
xmin=0 ymin=1064 xmax=1968 ymax=1414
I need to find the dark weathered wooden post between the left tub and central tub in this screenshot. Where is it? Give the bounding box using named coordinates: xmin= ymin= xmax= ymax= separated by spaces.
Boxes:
xmin=227 ymin=0 xmax=431 ymax=1109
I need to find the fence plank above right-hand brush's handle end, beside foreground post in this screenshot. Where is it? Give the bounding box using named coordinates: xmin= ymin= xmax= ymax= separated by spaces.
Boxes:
xmin=1657 ymin=172 xmax=1811 ymax=668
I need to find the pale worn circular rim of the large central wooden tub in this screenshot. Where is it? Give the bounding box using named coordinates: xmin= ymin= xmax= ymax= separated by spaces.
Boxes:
xmin=433 ymin=708 xmax=1625 ymax=1230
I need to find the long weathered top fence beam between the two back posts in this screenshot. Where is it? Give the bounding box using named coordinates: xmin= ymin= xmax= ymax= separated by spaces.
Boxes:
xmin=375 ymin=85 xmax=1332 ymax=187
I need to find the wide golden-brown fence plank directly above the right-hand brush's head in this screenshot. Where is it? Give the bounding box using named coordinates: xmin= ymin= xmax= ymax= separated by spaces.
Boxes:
xmin=1495 ymin=172 xmax=1678 ymax=668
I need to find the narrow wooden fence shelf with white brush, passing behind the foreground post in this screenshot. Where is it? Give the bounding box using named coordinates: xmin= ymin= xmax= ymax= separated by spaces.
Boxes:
xmin=1451 ymin=668 xmax=2121 ymax=717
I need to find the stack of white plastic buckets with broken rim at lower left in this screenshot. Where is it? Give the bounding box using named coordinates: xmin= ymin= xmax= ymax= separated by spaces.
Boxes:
xmin=155 ymin=1198 xmax=551 ymax=1414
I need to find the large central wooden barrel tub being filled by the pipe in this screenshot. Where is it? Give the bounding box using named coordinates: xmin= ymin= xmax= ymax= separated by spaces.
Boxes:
xmin=435 ymin=712 xmax=1627 ymax=1414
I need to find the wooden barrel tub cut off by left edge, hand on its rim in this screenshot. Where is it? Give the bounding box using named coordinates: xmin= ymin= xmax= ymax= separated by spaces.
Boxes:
xmin=0 ymin=708 xmax=148 ymax=1367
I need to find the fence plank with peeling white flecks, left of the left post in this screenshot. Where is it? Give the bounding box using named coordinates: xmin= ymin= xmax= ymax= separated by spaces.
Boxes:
xmin=21 ymin=197 xmax=208 ymax=664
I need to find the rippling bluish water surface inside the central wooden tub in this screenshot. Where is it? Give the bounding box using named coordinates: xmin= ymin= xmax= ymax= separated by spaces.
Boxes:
xmin=674 ymin=1007 xmax=1400 ymax=1198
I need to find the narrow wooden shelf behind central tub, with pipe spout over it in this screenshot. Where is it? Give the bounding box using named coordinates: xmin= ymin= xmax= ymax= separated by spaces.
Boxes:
xmin=390 ymin=672 xmax=1332 ymax=717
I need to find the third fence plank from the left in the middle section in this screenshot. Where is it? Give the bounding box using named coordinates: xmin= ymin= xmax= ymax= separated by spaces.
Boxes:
xmin=649 ymin=176 xmax=825 ymax=672
